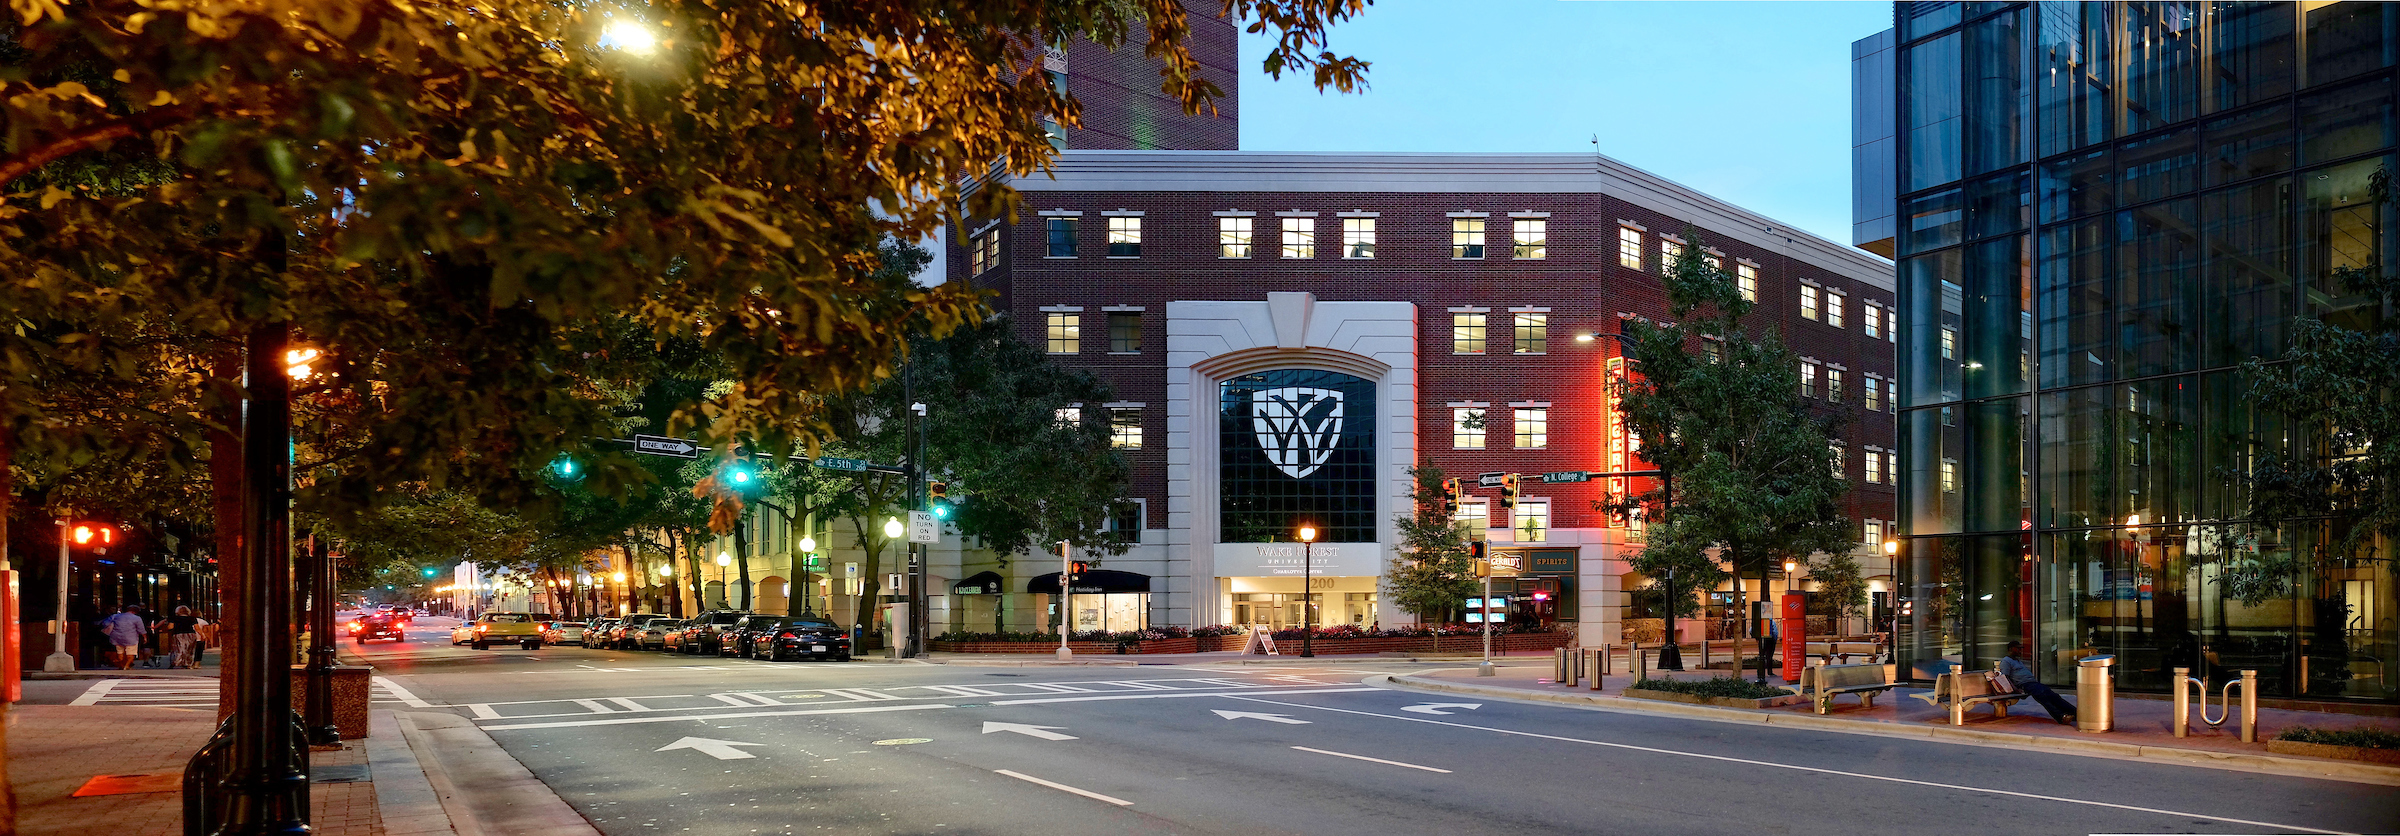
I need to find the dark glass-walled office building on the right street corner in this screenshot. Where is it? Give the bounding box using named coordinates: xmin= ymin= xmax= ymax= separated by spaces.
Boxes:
xmin=1855 ymin=2 xmax=2400 ymax=701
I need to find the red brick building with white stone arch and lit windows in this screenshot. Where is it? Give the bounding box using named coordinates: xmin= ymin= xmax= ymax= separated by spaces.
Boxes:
xmin=936 ymin=147 xmax=1894 ymax=641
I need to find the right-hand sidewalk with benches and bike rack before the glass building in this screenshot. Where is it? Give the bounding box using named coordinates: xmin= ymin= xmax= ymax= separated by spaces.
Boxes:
xmin=1387 ymin=658 xmax=2400 ymax=786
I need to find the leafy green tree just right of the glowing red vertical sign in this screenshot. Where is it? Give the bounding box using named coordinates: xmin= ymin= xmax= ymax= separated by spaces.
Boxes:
xmin=1603 ymin=231 xmax=1855 ymax=682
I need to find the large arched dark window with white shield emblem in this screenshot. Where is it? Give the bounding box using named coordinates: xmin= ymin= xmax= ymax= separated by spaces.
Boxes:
xmin=1217 ymin=370 xmax=1378 ymax=543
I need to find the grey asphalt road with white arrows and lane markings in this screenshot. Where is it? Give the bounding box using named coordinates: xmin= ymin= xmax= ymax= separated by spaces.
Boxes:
xmin=37 ymin=620 xmax=2400 ymax=836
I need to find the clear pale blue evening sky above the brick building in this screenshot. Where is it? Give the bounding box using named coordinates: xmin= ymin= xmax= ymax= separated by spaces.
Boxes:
xmin=1241 ymin=0 xmax=1891 ymax=245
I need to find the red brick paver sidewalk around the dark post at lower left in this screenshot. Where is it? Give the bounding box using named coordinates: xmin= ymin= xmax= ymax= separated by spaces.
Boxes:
xmin=7 ymin=706 xmax=384 ymax=836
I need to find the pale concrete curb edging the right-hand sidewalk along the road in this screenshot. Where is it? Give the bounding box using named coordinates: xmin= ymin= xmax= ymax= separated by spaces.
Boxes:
xmin=1366 ymin=675 xmax=2400 ymax=786
